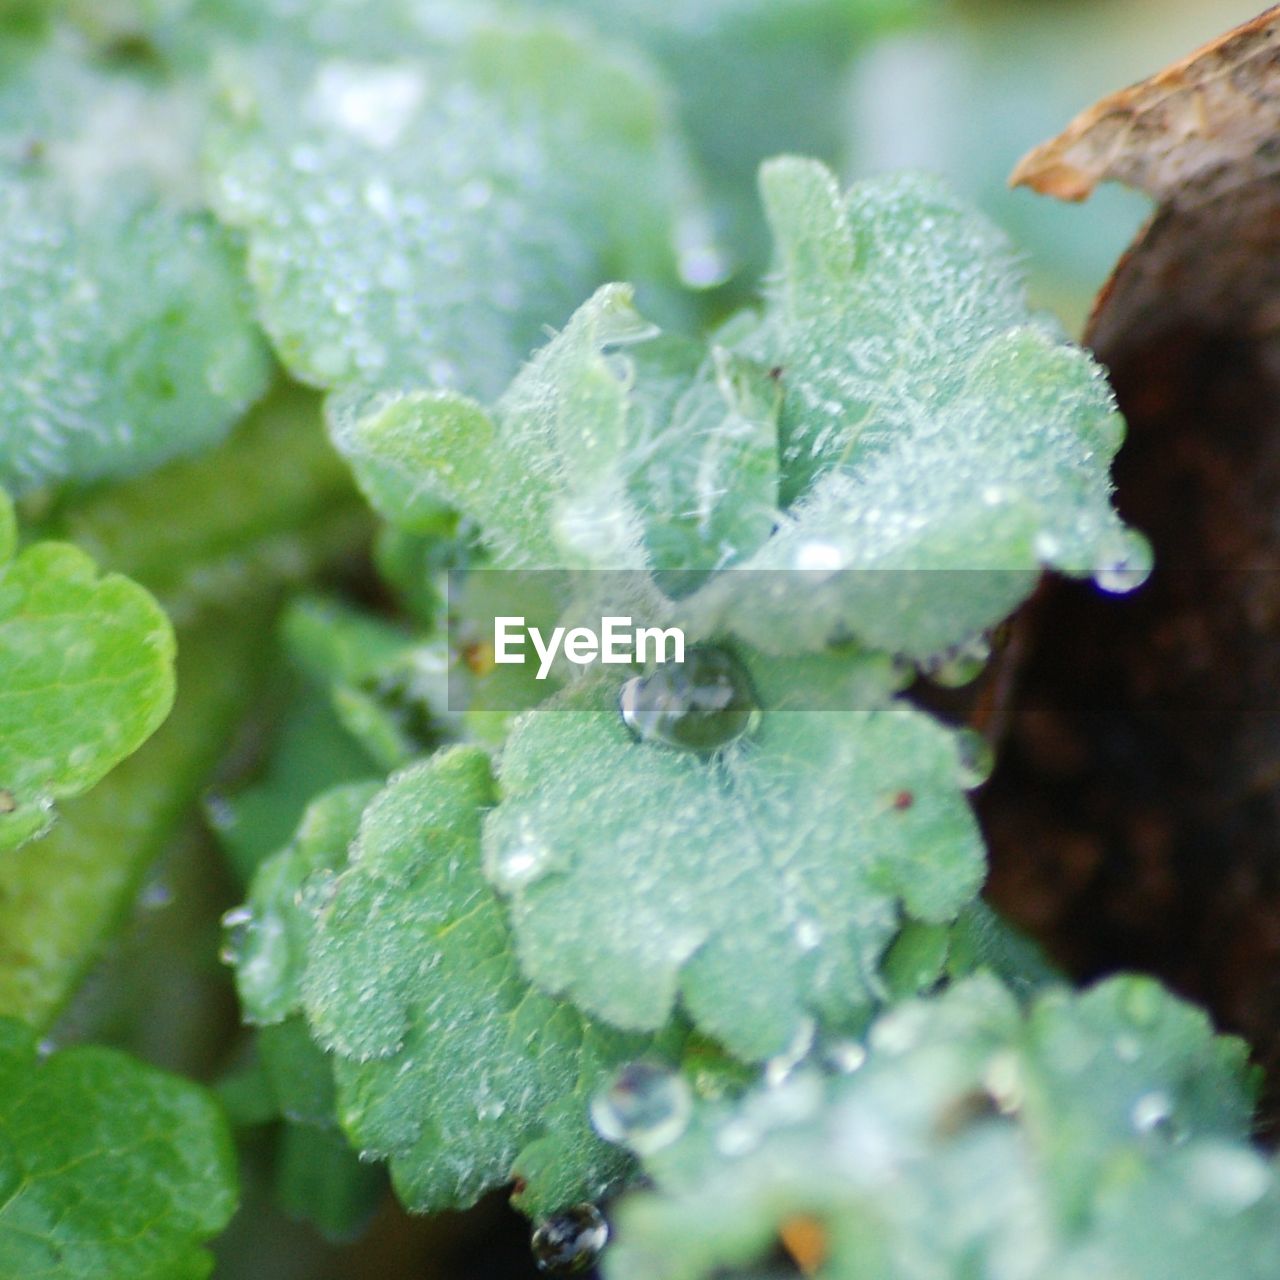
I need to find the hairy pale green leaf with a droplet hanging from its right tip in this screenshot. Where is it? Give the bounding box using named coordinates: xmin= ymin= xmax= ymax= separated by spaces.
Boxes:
xmin=699 ymin=159 xmax=1151 ymax=658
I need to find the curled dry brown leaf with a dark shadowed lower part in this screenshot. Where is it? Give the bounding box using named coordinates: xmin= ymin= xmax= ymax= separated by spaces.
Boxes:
xmin=980 ymin=6 xmax=1280 ymax=1120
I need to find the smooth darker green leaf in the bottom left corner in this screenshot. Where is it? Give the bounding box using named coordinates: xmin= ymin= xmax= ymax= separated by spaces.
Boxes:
xmin=0 ymin=1019 xmax=237 ymax=1280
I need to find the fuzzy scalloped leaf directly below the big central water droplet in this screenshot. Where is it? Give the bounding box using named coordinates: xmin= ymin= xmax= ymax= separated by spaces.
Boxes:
xmin=484 ymin=658 xmax=983 ymax=1060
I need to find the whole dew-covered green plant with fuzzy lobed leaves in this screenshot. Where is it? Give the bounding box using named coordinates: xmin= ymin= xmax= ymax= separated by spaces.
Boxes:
xmin=0 ymin=0 xmax=1264 ymax=1280
